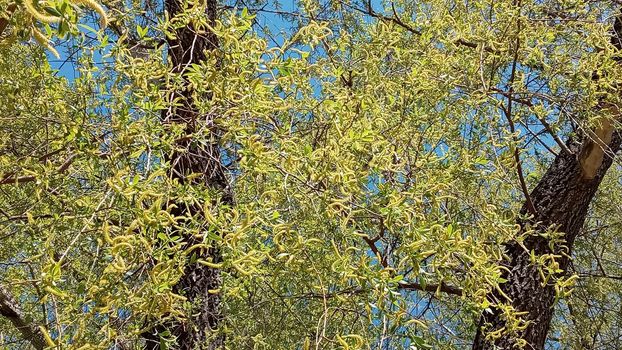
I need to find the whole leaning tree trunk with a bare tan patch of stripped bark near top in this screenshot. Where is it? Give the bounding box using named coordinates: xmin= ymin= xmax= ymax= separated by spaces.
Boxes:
xmin=473 ymin=11 xmax=622 ymax=350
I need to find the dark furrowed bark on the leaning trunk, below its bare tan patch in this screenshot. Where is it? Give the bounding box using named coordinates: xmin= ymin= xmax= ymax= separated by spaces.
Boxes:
xmin=473 ymin=133 xmax=622 ymax=350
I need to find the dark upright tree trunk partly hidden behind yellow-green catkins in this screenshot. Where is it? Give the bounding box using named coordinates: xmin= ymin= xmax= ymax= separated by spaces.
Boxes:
xmin=145 ymin=0 xmax=233 ymax=350
